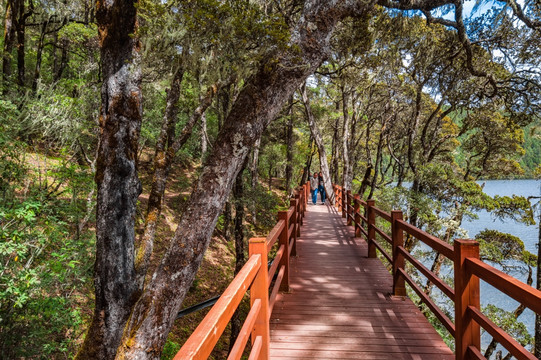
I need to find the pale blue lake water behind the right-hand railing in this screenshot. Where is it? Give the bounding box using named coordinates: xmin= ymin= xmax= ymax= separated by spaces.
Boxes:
xmin=462 ymin=180 xmax=541 ymax=346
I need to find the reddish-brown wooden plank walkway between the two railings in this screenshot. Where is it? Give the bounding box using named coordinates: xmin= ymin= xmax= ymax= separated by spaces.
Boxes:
xmin=270 ymin=204 xmax=454 ymax=360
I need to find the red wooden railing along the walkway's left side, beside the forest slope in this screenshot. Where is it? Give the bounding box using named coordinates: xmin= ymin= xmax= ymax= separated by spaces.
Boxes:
xmin=174 ymin=183 xmax=310 ymax=360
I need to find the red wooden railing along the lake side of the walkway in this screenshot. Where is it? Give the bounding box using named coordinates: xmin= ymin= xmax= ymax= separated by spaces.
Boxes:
xmin=333 ymin=185 xmax=541 ymax=360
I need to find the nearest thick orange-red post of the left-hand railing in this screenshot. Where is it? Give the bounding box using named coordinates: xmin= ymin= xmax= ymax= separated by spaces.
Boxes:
xmin=249 ymin=238 xmax=270 ymax=360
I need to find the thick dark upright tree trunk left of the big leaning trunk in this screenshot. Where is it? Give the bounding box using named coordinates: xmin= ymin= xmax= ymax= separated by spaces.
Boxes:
xmin=77 ymin=0 xmax=142 ymax=359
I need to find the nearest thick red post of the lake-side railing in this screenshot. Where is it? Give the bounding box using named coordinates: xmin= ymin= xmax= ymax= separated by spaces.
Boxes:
xmin=454 ymin=240 xmax=481 ymax=360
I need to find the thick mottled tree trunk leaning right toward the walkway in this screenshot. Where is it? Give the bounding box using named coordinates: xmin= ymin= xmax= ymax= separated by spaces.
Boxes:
xmin=113 ymin=0 xmax=361 ymax=359
